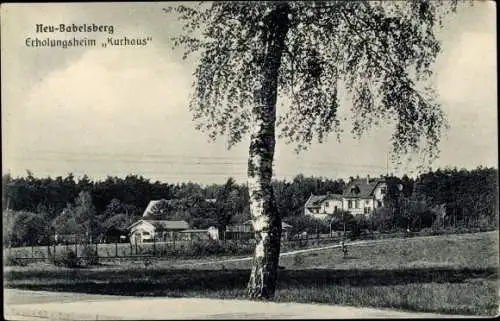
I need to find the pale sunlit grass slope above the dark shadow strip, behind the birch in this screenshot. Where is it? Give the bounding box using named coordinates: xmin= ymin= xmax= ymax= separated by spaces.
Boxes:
xmin=212 ymin=232 xmax=499 ymax=270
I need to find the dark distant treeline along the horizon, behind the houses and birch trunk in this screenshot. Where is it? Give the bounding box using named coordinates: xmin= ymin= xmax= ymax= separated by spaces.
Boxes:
xmin=2 ymin=167 xmax=498 ymax=243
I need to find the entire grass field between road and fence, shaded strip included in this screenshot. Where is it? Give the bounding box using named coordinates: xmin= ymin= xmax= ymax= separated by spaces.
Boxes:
xmin=4 ymin=232 xmax=499 ymax=315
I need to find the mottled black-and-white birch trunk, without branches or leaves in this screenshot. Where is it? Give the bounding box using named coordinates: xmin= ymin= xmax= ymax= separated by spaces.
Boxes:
xmin=248 ymin=4 xmax=288 ymax=299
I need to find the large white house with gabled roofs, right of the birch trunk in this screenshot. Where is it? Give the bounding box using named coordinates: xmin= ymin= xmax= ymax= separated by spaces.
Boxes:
xmin=304 ymin=176 xmax=387 ymax=219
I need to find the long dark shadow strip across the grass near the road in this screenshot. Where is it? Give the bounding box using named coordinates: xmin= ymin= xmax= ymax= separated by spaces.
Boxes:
xmin=4 ymin=268 xmax=498 ymax=297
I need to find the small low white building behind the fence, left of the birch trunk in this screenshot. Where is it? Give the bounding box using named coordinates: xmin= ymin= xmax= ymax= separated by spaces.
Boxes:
xmin=128 ymin=219 xmax=189 ymax=244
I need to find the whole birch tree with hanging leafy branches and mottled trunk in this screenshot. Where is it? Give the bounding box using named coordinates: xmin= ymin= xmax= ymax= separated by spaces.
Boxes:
xmin=165 ymin=1 xmax=456 ymax=299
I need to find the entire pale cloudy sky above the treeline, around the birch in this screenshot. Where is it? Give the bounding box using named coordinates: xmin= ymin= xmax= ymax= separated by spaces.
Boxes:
xmin=1 ymin=1 xmax=498 ymax=184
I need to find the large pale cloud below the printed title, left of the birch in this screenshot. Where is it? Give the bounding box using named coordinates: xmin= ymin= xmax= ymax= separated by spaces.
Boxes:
xmin=9 ymin=48 xmax=197 ymax=155
